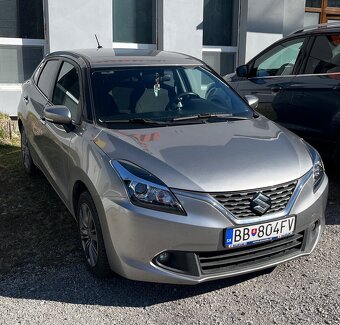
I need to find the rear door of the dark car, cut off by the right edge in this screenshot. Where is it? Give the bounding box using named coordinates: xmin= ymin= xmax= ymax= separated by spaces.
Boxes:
xmin=286 ymin=32 xmax=340 ymax=152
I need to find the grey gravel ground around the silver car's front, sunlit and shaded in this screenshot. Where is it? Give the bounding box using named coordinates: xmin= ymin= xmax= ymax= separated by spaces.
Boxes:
xmin=0 ymin=182 xmax=340 ymax=324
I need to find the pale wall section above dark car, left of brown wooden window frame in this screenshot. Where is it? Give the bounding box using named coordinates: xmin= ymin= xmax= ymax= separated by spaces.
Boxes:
xmin=240 ymin=0 xmax=305 ymax=64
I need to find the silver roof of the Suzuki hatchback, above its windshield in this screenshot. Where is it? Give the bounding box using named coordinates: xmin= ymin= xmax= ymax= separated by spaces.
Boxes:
xmin=48 ymin=48 xmax=204 ymax=68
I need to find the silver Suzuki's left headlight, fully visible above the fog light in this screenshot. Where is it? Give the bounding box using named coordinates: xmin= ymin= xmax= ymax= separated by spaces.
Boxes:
xmin=110 ymin=160 xmax=186 ymax=215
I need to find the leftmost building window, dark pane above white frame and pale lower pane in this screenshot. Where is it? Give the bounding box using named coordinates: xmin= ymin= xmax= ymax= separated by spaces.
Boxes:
xmin=0 ymin=0 xmax=44 ymax=84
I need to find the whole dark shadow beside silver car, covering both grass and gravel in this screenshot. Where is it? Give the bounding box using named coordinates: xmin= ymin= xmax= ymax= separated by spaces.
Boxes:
xmin=0 ymin=142 xmax=340 ymax=307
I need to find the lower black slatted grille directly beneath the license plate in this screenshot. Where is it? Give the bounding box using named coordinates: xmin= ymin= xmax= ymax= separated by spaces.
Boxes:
xmin=197 ymin=233 xmax=303 ymax=274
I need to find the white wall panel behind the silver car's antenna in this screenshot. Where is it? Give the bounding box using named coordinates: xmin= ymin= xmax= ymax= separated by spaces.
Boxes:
xmin=45 ymin=0 xmax=112 ymax=52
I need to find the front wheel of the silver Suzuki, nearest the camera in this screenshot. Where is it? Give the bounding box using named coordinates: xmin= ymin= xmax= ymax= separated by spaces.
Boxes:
xmin=77 ymin=191 xmax=112 ymax=278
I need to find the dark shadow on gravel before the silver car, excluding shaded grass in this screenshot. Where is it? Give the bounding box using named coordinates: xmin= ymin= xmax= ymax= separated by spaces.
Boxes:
xmin=0 ymin=258 xmax=265 ymax=307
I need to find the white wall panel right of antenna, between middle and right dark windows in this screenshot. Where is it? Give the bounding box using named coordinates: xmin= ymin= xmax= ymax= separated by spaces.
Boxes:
xmin=157 ymin=0 xmax=203 ymax=59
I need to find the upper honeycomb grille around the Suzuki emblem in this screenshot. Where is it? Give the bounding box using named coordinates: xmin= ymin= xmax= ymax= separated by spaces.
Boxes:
xmin=210 ymin=181 xmax=297 ymax=218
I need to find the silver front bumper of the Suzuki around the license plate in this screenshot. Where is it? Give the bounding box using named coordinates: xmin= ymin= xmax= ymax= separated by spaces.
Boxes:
xmin=102 ymin=173 xmax=328 ymax=284
